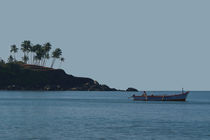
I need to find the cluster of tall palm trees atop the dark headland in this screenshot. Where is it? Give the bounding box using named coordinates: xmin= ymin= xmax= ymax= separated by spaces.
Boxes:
xmin=8 ymin=40 xmax=64 ymax=68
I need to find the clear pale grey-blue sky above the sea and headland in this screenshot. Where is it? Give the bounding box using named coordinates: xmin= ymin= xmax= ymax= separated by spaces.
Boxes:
xmin=0 ymin=0 xmax=210 ymax=90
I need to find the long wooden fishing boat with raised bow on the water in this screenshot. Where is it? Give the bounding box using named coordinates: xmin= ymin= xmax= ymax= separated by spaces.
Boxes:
xmin=132 ymin=90 xmax=189 ymax=101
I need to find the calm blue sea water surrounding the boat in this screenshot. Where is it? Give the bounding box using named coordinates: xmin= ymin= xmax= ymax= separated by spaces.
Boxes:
xmin=0 ymin=91 xmax=210 ymax=140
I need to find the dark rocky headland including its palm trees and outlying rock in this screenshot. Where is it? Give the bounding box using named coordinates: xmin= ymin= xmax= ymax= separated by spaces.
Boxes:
xmin=0 ymin=40 xmax=138 ymax=91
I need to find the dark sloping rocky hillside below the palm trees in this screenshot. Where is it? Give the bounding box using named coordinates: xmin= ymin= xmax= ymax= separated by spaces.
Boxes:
xmin=0 ymin=63 xmax=116 ymax=91
